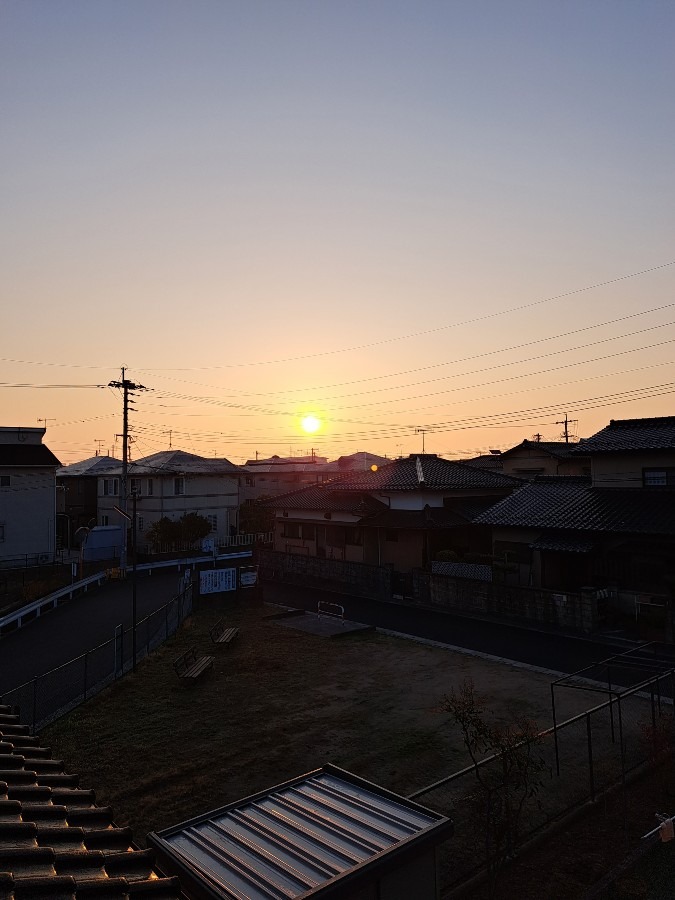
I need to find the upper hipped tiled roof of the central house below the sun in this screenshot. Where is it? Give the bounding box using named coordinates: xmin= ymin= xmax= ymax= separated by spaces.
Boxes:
xmin=320 ymin=453 xmax=522 ymax=492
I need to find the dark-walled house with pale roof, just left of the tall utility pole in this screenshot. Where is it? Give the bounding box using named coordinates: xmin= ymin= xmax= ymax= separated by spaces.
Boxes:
xmin=56 ymin=456 xmax=120 ymax=548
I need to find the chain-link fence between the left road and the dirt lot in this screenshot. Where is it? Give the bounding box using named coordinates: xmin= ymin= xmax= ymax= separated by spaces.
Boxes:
xmin=0 ymin=583 xmax=192 ymax=734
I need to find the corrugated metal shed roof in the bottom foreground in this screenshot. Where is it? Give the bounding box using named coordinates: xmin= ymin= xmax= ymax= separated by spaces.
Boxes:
xmin=148 ymin=766 xmax=452 ymax=900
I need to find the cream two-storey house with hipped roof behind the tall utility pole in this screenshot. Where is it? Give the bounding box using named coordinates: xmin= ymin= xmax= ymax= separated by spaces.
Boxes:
xmin=97 ymin=450 xmax=242 ymax=546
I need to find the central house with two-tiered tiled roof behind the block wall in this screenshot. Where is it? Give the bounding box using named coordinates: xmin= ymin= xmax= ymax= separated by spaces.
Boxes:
xmin=268 ymin=454 xmax=522 ymax=572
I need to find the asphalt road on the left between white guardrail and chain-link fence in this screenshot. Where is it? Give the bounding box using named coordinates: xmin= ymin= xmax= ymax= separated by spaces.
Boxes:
xmin=0 ymin=571 xmax=186 ymax=694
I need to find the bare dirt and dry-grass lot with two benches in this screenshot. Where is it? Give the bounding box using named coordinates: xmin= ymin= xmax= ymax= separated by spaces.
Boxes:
xmin=42 ymin=599 xmax=664 ymax=897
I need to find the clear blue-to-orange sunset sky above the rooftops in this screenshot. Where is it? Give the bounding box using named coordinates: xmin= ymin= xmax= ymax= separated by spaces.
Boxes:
xmin=0 ymin=0 xmax=675 ymax=464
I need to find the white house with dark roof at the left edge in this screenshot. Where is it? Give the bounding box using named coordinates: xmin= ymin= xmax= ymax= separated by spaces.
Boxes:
xmin=0 ymin=427 xmax=61 ymax=566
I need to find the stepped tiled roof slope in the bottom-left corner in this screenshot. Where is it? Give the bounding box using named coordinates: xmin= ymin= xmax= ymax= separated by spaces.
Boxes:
xmin=0 ymin=706 xmax=182 ymax=900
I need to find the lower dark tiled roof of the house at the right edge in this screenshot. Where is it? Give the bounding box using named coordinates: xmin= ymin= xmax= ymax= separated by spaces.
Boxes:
xmin=474 ymin=477 xmax=675 ymax=535
